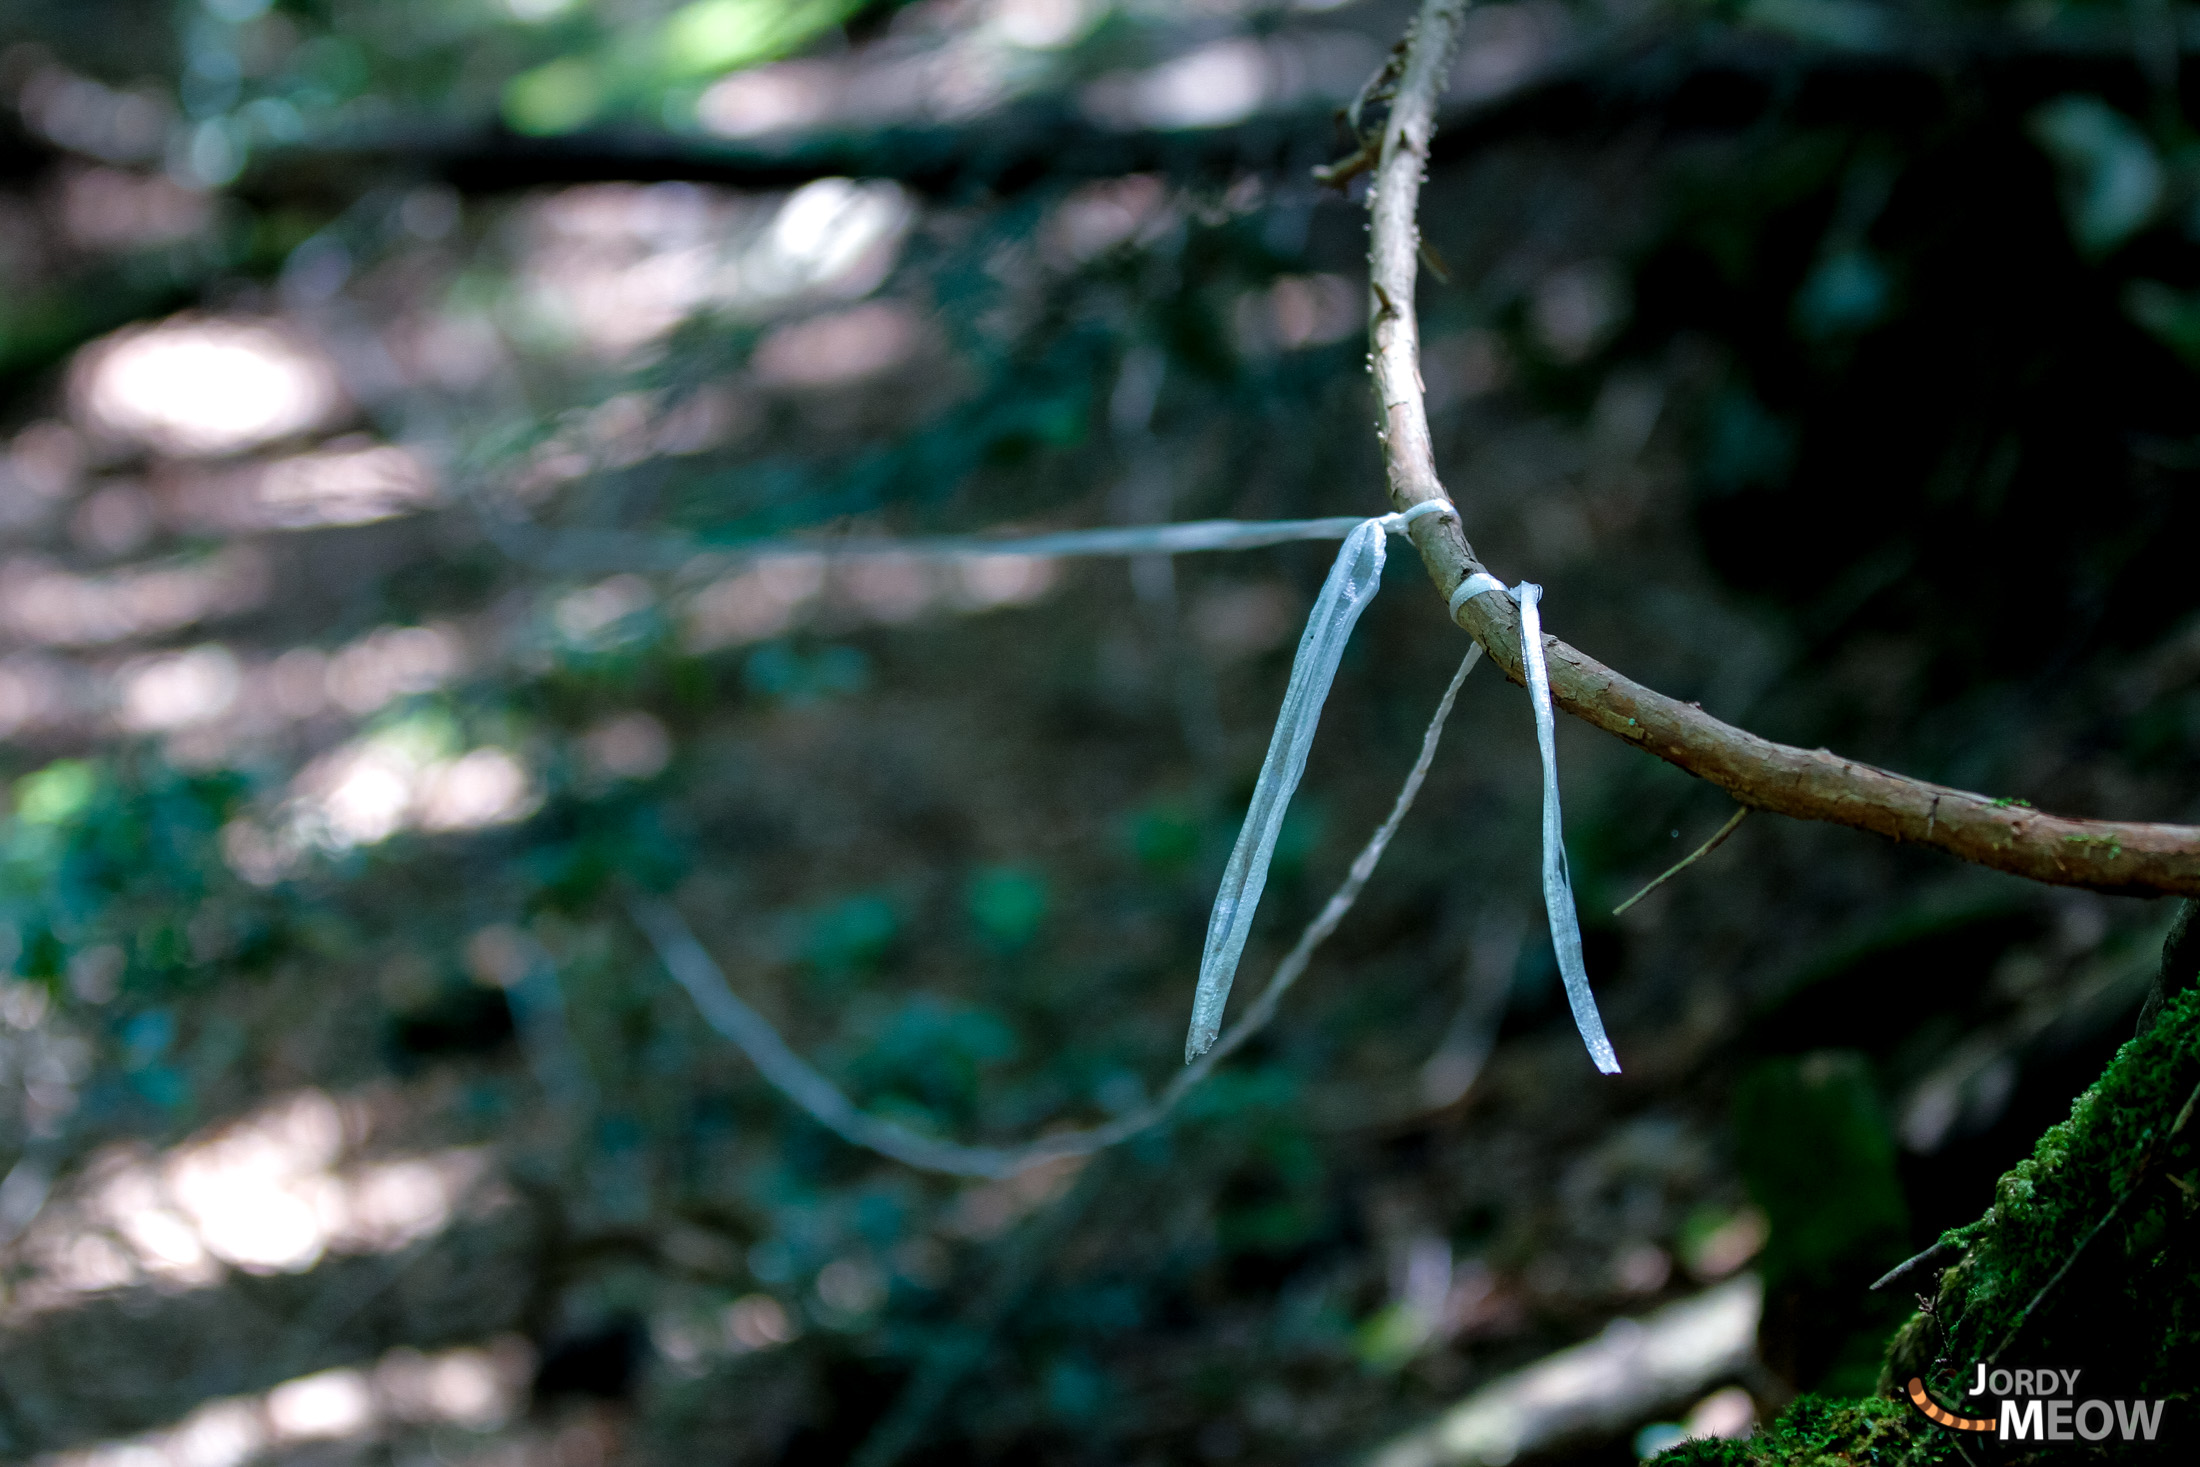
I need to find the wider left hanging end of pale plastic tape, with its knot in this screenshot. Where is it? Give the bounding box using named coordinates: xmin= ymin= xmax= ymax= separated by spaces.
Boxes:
xmin=1184 ymin=499 xmax=1459 ymax=1065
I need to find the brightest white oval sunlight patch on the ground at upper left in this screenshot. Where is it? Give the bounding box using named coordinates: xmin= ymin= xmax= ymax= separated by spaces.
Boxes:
xmin=70 ymin=317 xmax=343 ymax=457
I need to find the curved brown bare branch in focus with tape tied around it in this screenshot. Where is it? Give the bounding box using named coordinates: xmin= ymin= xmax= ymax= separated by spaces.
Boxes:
xmin=1368 ymin=0 xmax=2200 ymax=895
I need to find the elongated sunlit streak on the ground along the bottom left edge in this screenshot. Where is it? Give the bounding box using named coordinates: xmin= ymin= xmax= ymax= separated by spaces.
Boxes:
xmin=33 ymin=1337 xmax=535 ymax=1467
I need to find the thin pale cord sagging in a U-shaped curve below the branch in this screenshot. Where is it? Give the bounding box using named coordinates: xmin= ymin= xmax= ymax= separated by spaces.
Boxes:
xmin=627 ymin=647 xmax=1481 ymax=1177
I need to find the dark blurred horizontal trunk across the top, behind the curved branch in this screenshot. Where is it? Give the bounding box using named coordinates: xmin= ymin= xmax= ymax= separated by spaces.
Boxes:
xmin=198 ymin=11 xmax=2200 ymax=207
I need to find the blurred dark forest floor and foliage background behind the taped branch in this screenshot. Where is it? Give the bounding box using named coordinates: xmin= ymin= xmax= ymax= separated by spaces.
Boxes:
xmin=0 ymin=0 xmax=2200 ymax=1467
